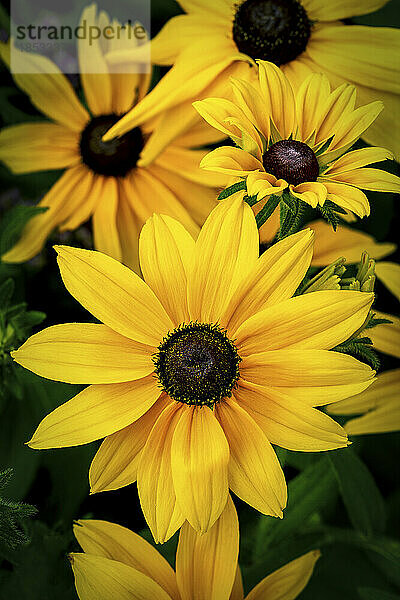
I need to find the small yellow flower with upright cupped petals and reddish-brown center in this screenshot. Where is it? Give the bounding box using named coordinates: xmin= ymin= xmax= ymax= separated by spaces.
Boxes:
xmin=194 ymin=61 xmax=400 ymax=217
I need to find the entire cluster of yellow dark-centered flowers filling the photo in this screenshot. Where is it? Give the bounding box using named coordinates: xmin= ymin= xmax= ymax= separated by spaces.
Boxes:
xmin=0 ymin=0 xmax=400 ymax=600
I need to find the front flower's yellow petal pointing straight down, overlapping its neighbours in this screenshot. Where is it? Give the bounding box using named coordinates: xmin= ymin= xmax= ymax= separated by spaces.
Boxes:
xmin=171 ymin=405 xmax=229 ymax=533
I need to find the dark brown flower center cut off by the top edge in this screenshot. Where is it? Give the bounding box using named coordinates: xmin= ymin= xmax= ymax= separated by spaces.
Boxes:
xmin=232 ymin=0 xmax=311 ymax=66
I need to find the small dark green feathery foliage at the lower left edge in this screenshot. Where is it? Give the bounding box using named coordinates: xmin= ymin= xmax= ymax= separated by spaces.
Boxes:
xmin=0 ymin=469 xmax=37 ymax=552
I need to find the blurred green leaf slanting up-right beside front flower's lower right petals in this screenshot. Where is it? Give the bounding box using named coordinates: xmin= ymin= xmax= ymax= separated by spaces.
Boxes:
xmin=253 ymin=458 xmax=337 ymax=560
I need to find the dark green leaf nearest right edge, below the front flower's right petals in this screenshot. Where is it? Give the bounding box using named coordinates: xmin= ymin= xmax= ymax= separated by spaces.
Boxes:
xmin=327 ymin=448 xmax=386 ymax=536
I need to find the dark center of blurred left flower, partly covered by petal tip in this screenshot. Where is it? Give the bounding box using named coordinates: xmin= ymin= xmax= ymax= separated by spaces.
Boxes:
xmin=80 ymin=114 xmax=144 ymax=177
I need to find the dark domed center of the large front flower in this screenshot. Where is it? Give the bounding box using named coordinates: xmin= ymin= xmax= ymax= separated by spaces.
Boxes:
xmin=153 ymin=322 xmax=241 ymax=408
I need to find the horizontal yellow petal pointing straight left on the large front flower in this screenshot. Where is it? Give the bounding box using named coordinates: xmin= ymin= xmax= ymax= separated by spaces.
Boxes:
xmin=12 ymin=323 xmax=154 ymax=383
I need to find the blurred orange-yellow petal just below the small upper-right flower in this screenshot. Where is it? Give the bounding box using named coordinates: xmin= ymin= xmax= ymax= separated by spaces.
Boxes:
xmin=307 ymin=220 xmax=396 ymax=267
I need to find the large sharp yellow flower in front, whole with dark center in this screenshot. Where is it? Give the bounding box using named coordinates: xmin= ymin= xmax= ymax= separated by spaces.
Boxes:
xmin=13 ymin=195 xmax=374 ymax=542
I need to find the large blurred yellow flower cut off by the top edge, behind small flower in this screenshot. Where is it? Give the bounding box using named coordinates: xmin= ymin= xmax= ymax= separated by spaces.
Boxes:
xmin=104 ymin=0 xmax=400 ymax=158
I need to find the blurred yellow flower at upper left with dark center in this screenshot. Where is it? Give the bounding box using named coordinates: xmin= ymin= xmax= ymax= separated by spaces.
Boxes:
xmin=0 ymin=4 xmax=222 ymax=270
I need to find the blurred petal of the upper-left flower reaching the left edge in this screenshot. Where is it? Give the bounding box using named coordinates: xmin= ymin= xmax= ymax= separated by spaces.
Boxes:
xmin=0 ymin=123 xmax=80 ymax=173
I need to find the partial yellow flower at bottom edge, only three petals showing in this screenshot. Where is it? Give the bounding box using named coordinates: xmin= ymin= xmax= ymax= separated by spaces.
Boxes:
xmin=69 ymin=499 xmax=320 ymax=600
